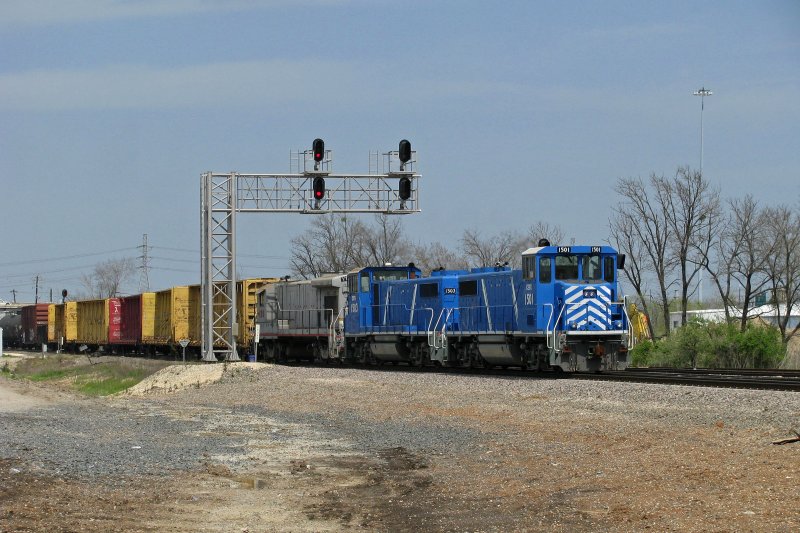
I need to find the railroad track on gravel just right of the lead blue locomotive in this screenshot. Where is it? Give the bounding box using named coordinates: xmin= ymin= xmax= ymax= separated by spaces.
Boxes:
xmin=571 ymin=368 xmax=800 ymax=392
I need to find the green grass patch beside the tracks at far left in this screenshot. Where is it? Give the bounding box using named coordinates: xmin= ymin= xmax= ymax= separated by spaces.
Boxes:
xmin=14 ymin=355 xmax=170 ymax=396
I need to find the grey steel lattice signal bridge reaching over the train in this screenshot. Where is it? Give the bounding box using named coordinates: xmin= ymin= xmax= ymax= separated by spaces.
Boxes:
xmin=200 ymin=148 xmax=421 ymax=361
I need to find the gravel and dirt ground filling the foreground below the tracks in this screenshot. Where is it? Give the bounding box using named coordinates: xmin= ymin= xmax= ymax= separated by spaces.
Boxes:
xmin=0 ymin=365 xmax=800 ymax=531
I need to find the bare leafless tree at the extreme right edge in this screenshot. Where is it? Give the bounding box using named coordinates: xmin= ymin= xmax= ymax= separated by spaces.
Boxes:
xmin=764 ymin=206 xmax=800 ymax=343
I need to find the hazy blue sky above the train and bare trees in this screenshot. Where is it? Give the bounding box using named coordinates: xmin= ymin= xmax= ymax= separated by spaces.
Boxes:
xmin=0 ymin=0 xmax=800 ymax=301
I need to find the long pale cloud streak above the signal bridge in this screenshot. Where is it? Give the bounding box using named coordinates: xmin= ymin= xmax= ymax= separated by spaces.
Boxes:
xmin=0 ymin=60 xmax=521 ymax=111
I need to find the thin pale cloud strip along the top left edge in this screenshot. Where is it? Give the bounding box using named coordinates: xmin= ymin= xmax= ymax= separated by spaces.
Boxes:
xmin=0 ymin=0 xmax=349 ymax=28
